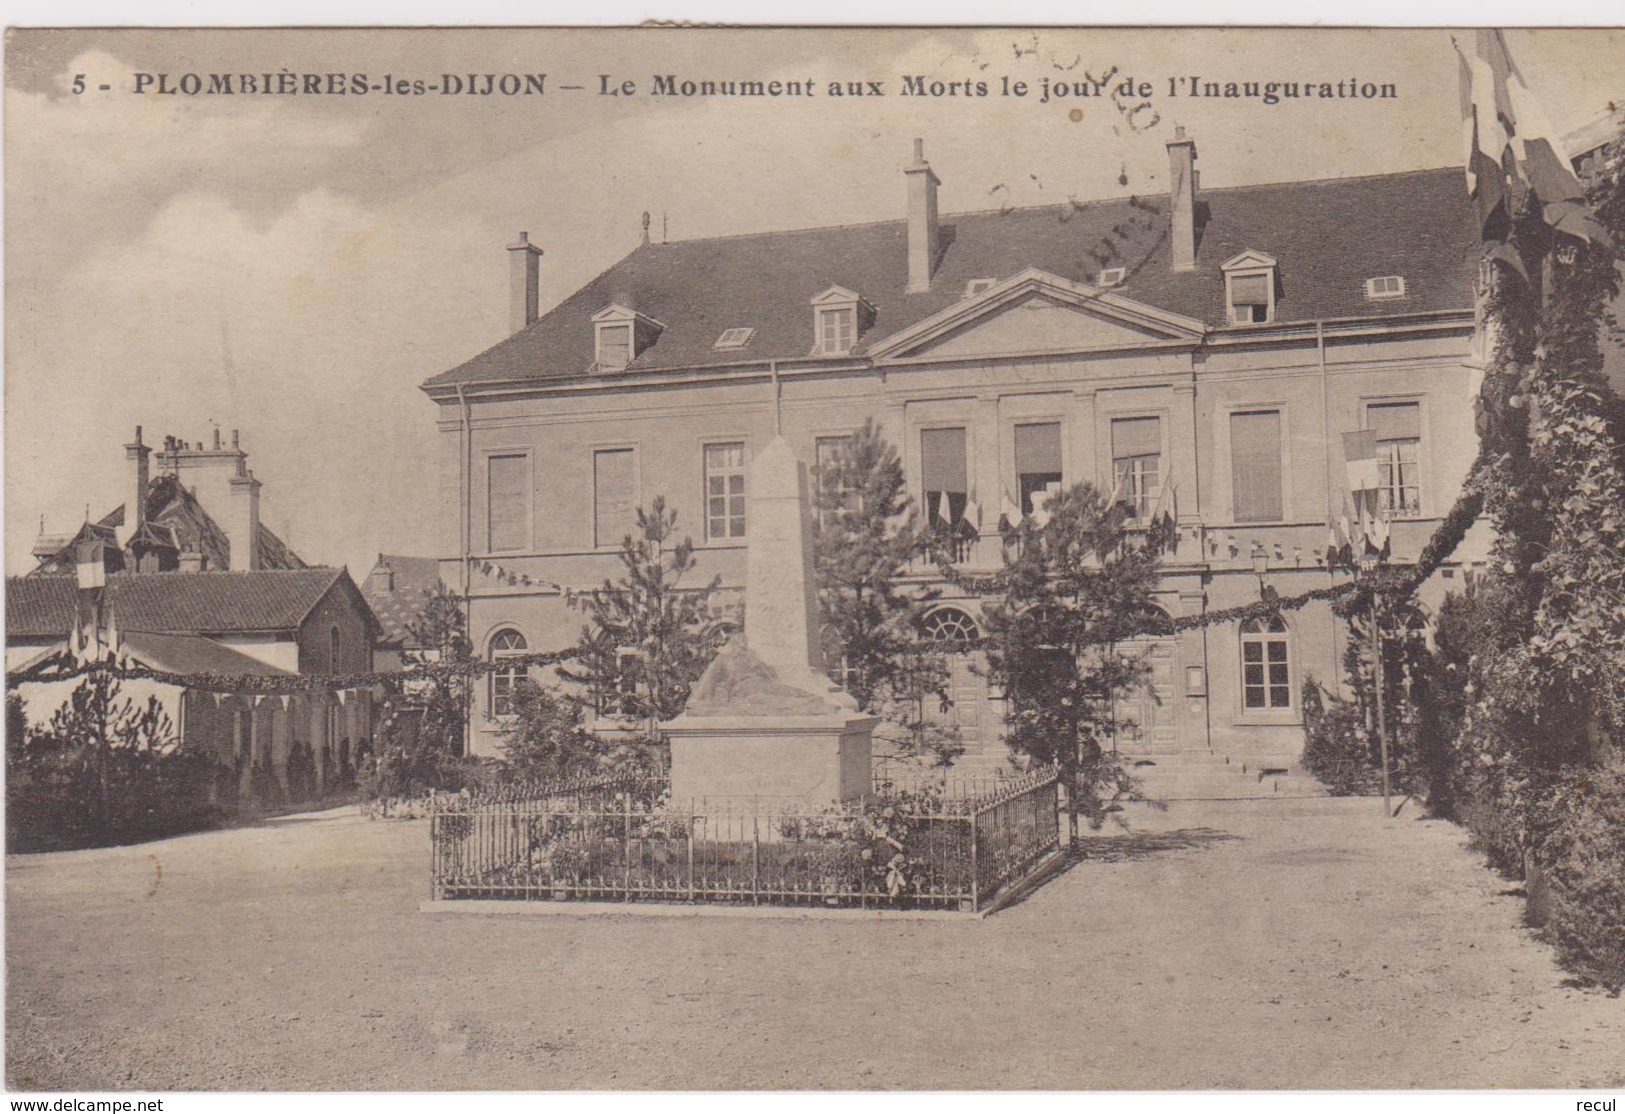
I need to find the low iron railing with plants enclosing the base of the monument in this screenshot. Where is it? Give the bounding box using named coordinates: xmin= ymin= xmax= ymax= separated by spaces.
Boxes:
xmin=429 ymin=770 xmax=1060 ymax=911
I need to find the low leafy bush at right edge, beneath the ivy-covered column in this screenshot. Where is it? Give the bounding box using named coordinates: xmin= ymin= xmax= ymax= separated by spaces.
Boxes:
xmin=1534 ymin=765 xmax=1625 ymax=992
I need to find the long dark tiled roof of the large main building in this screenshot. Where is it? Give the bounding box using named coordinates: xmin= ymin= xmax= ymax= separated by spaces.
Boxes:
xmin=426 ymin=169 xmax=1479 ymax=386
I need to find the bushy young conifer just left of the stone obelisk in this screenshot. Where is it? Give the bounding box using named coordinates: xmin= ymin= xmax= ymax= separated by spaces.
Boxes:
xmin=559 ymin=495 xmax=728 ymax=745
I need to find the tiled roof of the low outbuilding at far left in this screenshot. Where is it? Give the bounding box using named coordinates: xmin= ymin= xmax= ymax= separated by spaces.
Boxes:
xmin=5 ymin=568 xmax=351 ymax=638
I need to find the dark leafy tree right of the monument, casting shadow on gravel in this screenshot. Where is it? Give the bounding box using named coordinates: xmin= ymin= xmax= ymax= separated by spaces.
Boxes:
xmin=943 ymin=482 xmax=1168 ymax=830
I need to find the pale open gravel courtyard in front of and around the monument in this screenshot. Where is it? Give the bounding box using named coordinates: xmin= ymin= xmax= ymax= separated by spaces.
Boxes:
xmin=7 ymin=799 xmax=1625 ymax=1090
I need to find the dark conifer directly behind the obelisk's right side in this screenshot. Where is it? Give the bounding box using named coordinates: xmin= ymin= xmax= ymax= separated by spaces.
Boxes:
xmin=814 ymin=421 xmax=964 ymax=765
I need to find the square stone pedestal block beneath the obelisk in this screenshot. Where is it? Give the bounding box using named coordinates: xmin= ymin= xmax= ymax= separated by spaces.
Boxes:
xmin=666 ymin=716 xmax=879 ymax=810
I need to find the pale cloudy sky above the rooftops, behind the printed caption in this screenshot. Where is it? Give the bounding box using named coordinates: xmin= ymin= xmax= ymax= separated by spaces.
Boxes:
xmin=5 ymin=29 xmax=1625 ymax=576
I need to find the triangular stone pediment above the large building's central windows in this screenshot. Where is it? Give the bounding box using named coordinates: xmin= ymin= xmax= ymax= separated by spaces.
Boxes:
xmin=869 ymin=270 xmax=1206 ymax=362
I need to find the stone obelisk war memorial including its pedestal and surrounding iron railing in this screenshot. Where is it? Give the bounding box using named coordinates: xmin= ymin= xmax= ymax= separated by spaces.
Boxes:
xmin=427 ymin=437 xmax=1061 ymax=913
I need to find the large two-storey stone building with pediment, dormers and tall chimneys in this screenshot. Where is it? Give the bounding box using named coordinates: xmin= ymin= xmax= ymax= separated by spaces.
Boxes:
xmin=424 ymin=133 xmax=1479 ymax=772
